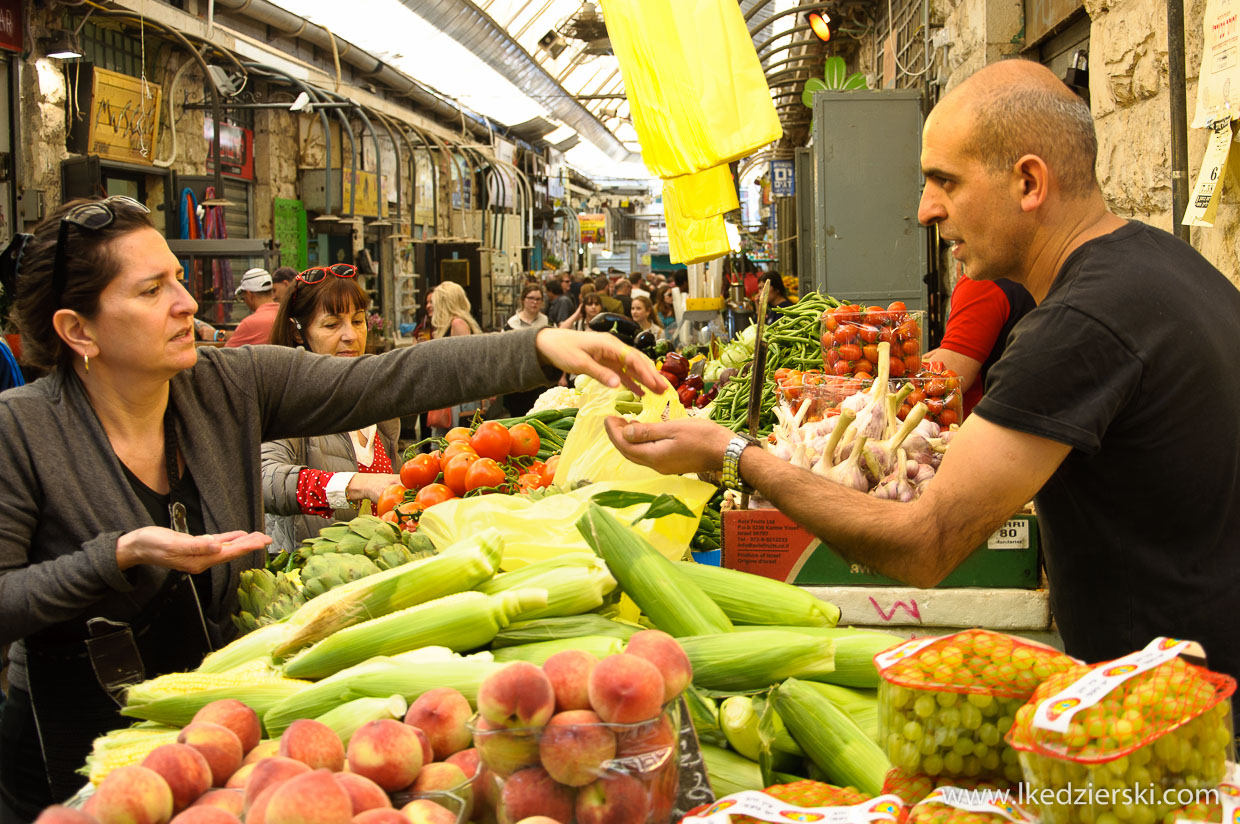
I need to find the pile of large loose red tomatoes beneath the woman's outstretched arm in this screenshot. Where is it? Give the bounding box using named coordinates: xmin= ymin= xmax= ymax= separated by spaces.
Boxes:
xmin=374 ymin=420 xmax=559 ymax=530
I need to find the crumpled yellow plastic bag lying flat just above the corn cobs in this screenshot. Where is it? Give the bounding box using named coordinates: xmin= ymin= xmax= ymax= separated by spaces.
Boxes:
xmin=418 ymin=473 xmax=714 ymax=570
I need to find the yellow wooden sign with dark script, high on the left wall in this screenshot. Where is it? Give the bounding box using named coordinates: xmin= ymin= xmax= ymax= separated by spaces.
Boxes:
xmin=88 ymin=68 xmax=160 ymax=164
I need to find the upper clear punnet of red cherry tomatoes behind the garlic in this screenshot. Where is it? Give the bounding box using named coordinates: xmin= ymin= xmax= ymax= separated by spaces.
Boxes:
xmin=822 ymin=300 xmax=921 ymax=378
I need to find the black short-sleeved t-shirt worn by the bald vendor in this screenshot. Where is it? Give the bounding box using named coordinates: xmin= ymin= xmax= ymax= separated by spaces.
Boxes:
xmin=976 ymin=222 xmax=1240 ymax=677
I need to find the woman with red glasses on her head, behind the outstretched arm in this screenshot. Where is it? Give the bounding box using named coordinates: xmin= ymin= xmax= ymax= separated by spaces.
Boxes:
xmin=263 ymin=264 xmax=401 ymax=553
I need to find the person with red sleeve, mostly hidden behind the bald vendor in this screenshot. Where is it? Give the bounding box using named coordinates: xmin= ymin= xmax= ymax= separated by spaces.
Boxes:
xmin=923 ymin=274 xmax=1034 ymax=415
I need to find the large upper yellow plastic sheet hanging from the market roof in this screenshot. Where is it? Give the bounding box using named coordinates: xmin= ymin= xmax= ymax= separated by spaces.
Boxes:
xmin=603 ymin=0 xmax=782 ymax=177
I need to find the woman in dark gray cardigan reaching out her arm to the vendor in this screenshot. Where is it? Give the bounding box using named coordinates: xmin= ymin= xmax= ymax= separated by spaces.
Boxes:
xmin=0 ymin=197 xmax=663 ymax=822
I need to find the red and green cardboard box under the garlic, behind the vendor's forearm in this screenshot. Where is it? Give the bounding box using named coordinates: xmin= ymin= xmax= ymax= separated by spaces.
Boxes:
xmin=723 ymin=509 xmax=1039 ymax=590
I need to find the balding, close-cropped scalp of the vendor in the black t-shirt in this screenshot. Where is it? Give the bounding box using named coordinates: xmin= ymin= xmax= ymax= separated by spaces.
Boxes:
xmin=940 ymin=59 xmax=1097 ymax=197
